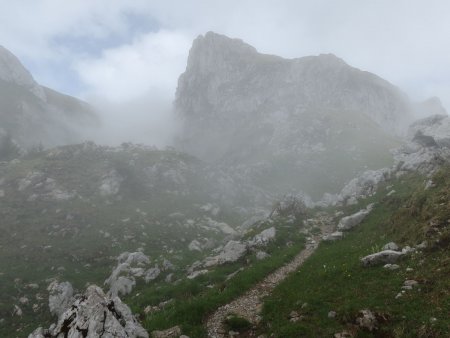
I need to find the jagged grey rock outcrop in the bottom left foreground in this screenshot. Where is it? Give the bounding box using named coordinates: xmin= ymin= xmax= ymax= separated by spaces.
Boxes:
xmin=28 ymin=285 xmax=148 ymax=338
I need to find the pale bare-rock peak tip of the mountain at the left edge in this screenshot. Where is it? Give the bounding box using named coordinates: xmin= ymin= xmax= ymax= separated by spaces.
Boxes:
xmin=0 ymin=46 xmax=46 ymax=101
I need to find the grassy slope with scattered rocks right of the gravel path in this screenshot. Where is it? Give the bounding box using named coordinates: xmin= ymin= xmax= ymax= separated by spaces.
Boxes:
xmin=260 ymin=168 xmax=450 ymax=337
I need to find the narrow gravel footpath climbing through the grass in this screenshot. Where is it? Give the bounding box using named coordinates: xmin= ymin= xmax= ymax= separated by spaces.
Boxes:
xmin=206 ymin=220 xmax=331 ymax=338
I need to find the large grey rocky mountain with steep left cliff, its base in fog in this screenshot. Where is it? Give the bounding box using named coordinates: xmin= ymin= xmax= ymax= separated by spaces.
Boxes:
xmin=175 ymin=32 xmax=418 ymax=198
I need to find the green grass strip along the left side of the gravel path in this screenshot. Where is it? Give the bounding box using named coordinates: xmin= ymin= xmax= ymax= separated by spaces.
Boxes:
xmin=133 ymin=220 xmax=304 ymax=337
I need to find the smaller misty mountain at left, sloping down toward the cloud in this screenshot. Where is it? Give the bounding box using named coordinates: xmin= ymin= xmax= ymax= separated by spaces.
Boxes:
xmin=0 ymin=46 xmax=99 ymax=148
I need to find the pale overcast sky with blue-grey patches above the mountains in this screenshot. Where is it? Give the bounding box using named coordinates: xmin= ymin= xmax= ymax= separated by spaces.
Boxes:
xmin=0 ymin=0 xmax=450 ymax=143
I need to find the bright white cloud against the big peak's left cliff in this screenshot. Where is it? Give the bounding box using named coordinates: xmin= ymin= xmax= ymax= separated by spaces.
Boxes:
xmin=75 ymin=30 xmax=191 ymax=102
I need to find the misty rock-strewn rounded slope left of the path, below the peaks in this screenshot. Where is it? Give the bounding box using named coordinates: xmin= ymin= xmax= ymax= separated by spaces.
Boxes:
xmin=0 ymin=143 xmax=270 ymax=337
